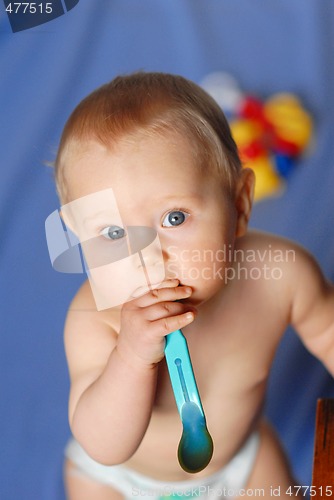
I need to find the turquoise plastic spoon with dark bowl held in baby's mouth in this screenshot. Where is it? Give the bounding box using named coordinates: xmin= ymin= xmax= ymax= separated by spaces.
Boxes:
xmin=165 ymin=330 xmax=213 ymax=472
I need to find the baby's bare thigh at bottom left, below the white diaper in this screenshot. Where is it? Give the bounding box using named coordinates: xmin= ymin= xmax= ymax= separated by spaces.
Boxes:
xmin=64 ymin=460 xmax=124 ymax=500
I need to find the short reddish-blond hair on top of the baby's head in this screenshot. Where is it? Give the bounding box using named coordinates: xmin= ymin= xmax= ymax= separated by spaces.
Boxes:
xmin=55 ymin=72 xmax=241 ymax=200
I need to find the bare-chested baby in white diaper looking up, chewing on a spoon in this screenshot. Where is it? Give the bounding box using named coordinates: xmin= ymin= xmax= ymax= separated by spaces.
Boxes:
xmin=52 ymin=73 xmax=334 ymax=500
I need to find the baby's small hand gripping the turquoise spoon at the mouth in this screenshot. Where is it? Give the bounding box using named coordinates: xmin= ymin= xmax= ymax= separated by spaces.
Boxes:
xmin=117 ymin=279 xmax=196 ymax=366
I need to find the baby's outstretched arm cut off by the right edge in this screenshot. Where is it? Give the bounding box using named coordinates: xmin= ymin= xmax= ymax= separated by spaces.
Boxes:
xmin=286 ymin=243 xmax=334 ymax=376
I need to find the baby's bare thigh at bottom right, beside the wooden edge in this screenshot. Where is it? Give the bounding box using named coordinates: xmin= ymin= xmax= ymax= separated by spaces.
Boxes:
xmin=241 ymin=423 xmax=301 ymax=500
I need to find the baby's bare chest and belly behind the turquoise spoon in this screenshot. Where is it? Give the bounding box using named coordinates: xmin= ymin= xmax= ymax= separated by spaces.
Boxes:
xmin=126 ymin=308 xmax=283 ymax=480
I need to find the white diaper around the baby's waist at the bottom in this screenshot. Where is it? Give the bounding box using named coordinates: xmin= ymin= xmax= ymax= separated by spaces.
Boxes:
xmin=65 ymin=432 xmax=260 ymax=500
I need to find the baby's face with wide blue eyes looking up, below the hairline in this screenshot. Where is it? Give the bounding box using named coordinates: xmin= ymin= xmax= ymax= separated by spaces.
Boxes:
xmin=62 ymin=131 xmax=237 ymax=305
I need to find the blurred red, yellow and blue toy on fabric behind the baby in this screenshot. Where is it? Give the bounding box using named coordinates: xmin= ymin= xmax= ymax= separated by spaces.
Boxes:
xmin=202 ymin=73 xmax=313 ymax=201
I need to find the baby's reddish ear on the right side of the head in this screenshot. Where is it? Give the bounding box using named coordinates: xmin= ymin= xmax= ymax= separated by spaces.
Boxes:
xmin=235 ymin=168 xmax=255 ymax=237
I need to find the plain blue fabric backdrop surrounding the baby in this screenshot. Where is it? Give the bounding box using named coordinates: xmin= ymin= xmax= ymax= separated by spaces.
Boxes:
xmin=0 ymin=0 xmax=334 ymax=500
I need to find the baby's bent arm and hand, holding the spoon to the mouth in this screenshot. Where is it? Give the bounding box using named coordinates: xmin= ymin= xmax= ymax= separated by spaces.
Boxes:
xmin=65 ymin=280 xmax=194 ymax=465
